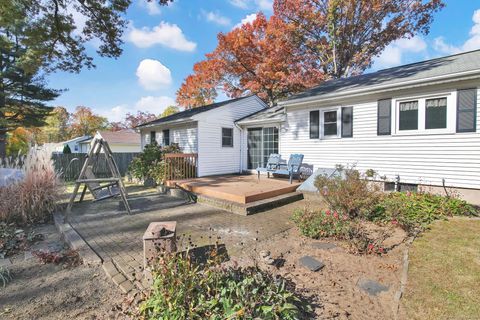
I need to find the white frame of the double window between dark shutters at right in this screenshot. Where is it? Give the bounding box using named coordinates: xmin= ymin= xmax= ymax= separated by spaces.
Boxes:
xmin=391 ymin=91 xmax=457 ymax=136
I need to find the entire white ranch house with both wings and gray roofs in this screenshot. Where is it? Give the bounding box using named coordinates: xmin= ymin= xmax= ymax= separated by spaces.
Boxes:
xmin=138 ymin=51 xmax=480 ymax=203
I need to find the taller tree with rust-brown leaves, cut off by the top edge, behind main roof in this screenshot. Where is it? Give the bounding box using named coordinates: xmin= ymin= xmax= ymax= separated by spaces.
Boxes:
xmin=273 ymin=0 xmax=444 ymax=78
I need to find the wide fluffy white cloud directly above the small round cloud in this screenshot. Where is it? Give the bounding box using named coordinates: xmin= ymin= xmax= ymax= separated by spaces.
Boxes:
xmin=127 ymin=21 xmax=197 ymax=51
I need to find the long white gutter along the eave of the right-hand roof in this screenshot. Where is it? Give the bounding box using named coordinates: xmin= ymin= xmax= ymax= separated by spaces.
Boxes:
xmin=278 ymin=69 xmax=480 ymax=107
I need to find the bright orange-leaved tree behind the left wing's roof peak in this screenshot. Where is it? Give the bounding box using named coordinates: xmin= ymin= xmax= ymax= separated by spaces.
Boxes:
xmin=177 ymin=13 xmax=323 ymax=108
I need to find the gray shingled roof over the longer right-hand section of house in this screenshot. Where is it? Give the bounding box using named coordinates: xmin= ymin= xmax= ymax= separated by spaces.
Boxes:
xmin=282 ymin=50 xmax=480 ymax=104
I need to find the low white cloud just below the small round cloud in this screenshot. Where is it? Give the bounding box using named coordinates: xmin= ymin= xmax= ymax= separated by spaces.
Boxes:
xmin=100 ymin=96 xmax=175 ymax=122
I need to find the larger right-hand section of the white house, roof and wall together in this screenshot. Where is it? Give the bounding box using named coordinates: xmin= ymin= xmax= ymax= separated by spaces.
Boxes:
xmin=260 ymin=51 xmax=480 ymax=203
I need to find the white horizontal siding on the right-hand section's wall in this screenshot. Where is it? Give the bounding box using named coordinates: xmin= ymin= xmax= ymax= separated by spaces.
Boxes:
xmin=279 ymin=86 xmax=480 ymax=189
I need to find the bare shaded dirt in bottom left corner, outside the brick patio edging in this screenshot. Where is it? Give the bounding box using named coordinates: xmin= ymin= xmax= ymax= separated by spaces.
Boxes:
xmin=0 ymin=225 xmax=123 ymax=319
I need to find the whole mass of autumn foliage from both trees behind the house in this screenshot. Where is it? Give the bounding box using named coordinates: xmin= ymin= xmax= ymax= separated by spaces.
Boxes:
xmin=177 ymin=0 xmax=444 ymax=108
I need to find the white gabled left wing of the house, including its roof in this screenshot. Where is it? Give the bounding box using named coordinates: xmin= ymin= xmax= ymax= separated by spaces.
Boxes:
xmin=137 ymin=96 xmax=267 ymax=176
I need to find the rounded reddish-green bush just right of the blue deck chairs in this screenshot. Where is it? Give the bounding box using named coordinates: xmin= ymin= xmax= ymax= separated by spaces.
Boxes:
xmin=315 ymin=166 xmax=382 ymax=218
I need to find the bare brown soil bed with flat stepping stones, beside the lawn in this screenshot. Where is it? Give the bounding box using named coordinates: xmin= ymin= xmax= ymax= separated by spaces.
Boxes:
xmin=233 ymin=228 xmax=405 ymax=319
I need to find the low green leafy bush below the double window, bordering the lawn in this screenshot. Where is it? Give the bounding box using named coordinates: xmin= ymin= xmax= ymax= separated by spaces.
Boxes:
xmin=369 ymin=192 xmax=476 ymax=233
